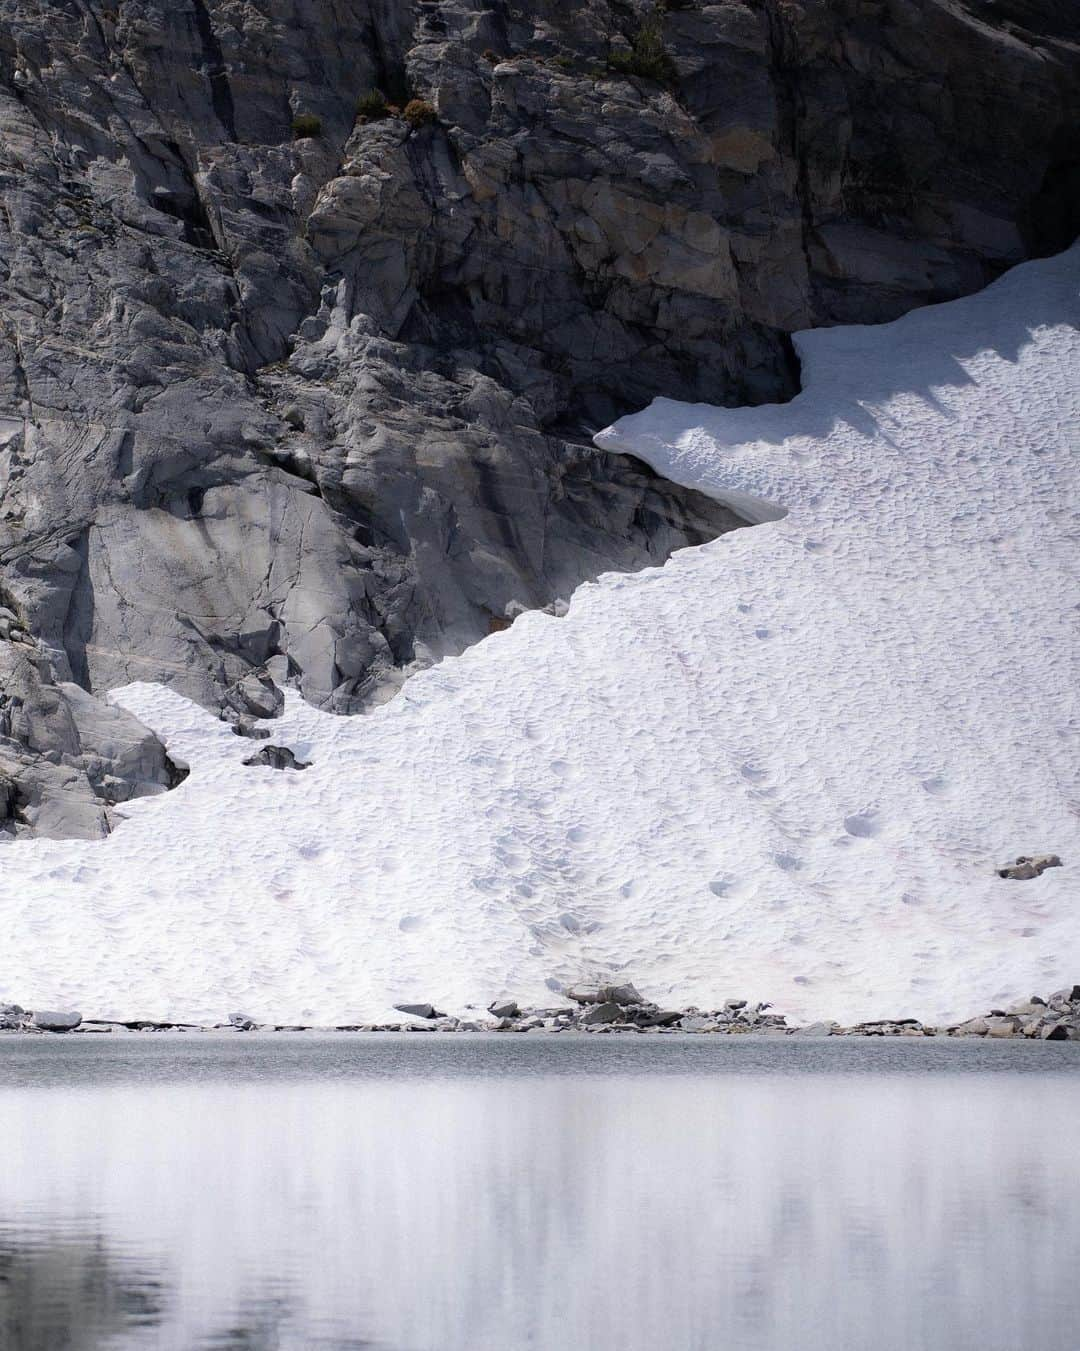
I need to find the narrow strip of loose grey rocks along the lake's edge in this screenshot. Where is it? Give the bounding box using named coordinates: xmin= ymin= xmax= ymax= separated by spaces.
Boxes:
xmin=0 ymin=984 xmax=1080 ymax=1042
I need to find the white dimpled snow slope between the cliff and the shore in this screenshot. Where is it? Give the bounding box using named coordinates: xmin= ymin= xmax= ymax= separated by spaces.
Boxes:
xmin=0 ymin=249 xmax=1080 ymax=1021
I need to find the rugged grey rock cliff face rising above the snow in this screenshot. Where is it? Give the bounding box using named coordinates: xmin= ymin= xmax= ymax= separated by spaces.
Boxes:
xmin=0 ymin=0 xmax=1080 ymax=834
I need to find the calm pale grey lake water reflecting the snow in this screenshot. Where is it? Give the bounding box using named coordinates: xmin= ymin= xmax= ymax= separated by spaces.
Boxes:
xmin=0 ymin=1034 xmax=1080 ymax=1351
